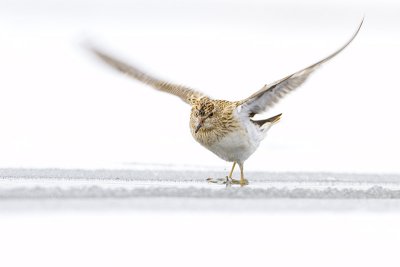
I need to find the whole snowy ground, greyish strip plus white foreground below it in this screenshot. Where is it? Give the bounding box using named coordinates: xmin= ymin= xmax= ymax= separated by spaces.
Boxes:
xmin=0 ymin=169 xmax=400 ymax=267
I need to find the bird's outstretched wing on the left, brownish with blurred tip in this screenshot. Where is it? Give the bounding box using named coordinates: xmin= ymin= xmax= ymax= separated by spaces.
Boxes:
xmin=90 ymin=47 xmax=204 ymax=104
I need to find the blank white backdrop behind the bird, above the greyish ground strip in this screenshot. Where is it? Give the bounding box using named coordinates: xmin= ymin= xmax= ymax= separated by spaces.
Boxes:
xmin=0 ymin=0 xmax=400 ymax=173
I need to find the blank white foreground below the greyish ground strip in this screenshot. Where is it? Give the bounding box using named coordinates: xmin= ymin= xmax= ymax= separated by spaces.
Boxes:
xmin=0 ymin=213 xmax=400 ymax=267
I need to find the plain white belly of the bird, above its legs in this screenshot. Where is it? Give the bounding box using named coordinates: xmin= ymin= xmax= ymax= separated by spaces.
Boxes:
xmin=208 ymin=131 xmax=260 ymax=162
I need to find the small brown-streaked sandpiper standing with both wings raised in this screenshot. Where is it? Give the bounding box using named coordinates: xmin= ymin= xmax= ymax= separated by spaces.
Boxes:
xmin=88 ymin=18 xmax=364 ymax=186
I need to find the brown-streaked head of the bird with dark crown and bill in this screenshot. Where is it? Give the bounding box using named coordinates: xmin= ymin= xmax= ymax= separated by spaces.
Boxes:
xmin=190 ymin=97 xmax=217 ymax=133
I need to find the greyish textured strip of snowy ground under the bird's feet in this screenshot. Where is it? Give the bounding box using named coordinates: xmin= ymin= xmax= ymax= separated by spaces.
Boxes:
xmin=0 ymin=169 xmax=400 ymax=212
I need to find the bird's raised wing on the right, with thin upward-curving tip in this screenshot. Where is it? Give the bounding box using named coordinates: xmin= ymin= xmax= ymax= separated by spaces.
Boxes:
xmin=238 ymin=19 xmax=364 ymax=116
